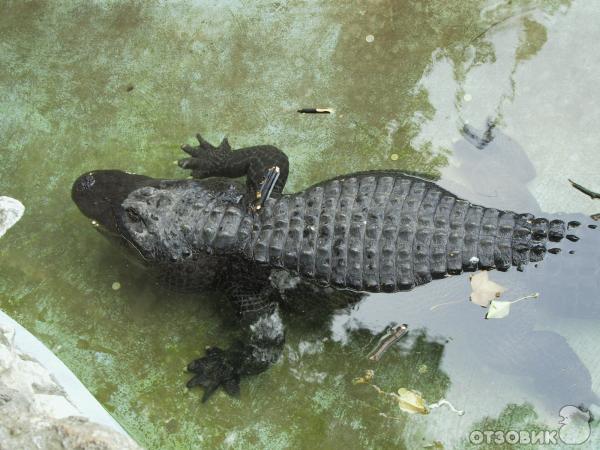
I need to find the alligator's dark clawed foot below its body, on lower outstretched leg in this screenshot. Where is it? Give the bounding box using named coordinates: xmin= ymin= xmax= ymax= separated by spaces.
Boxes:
xmin=187 ymin=347 xmax=240 ymax=403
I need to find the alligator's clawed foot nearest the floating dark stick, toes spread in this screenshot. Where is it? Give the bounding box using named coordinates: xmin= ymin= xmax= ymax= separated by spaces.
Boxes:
xmin=177 ymin=134 xmax=231 ymax=178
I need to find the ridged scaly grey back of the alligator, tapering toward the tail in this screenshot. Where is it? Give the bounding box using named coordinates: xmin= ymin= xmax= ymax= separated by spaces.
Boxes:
xmin=243 ymin=172 xmax=566 ymax=292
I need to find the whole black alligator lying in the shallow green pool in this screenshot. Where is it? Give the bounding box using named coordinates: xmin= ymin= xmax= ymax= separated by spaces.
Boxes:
xmin=72 ymin=135 xmax=576 ymax=401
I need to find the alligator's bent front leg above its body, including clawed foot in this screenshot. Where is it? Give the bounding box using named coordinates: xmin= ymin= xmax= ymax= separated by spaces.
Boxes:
xmin=178 ymin=134 xmax=289 ymax=200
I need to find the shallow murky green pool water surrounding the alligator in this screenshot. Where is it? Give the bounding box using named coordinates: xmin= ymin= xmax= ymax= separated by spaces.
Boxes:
xmin=0 ymin=0 xmax=600 ymax=449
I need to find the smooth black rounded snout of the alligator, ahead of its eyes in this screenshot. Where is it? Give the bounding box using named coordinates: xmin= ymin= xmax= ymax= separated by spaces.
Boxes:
xmin=71 ymin=170 xmax=157 ymax=251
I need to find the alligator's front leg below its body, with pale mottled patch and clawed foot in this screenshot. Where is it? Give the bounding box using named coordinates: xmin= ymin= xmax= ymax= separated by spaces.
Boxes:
xmin=187 ymin=268 xmax=284 ymax=402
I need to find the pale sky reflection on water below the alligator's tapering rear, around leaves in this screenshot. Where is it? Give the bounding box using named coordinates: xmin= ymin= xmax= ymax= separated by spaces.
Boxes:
xmin=332 ymin=216 xmax=600 ymax=439
